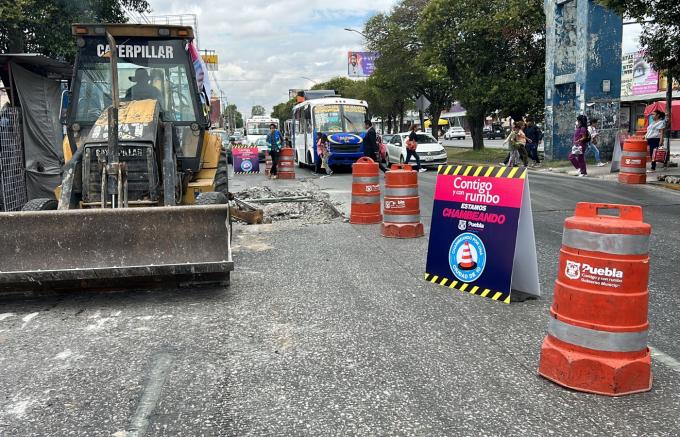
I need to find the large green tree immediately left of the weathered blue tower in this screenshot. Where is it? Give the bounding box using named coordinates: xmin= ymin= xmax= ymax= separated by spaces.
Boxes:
xmin=418 ymin=0 xmax=545 ymax=150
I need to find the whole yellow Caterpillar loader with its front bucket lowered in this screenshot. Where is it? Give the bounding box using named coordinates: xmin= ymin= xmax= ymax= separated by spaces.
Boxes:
xmin=0 ymin=24 xmax=233 ymax=291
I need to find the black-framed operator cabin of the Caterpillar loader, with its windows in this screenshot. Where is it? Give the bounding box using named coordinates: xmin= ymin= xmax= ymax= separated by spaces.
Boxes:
xmin=64 ymin=24 xmax=208 ymax=173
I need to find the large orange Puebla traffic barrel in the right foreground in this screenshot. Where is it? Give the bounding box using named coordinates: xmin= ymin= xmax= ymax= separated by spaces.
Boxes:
xmin=538 ymin=203 xmax=652 ymax=396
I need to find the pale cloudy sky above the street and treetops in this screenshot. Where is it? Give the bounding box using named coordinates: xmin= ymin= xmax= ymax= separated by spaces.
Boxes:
xmin=134 ymin=0 xmax=639 ymax=116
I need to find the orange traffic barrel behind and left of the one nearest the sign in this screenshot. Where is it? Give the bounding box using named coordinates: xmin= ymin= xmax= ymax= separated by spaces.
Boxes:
xmin=349 ymin=156 xmax=382 ymax=225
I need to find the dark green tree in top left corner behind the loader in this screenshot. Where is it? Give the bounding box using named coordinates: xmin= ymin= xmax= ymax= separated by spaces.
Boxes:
xmin=0 ymin=0 xmax=149 ymax=62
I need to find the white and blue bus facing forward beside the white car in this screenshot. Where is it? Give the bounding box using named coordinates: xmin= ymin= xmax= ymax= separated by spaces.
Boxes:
xmin=290 ymin=97 xmax=368 ymax=169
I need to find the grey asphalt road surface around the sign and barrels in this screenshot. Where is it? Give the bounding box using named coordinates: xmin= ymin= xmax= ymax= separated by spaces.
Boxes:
xmin=0 ymin=165 xmax=680 ymax=437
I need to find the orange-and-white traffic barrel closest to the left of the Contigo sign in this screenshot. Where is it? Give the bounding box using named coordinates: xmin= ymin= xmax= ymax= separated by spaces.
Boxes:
xmin=380 ymin=164 xmax=425 ymax=238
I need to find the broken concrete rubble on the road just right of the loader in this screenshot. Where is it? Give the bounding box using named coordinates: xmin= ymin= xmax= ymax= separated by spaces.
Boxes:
xmin=234 ymin=186 xmax=341 ymax=223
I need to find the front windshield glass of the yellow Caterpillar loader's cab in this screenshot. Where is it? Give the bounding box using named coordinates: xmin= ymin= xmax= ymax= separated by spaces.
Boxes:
xmin=74 ymin=38 xmax=197 ymax=122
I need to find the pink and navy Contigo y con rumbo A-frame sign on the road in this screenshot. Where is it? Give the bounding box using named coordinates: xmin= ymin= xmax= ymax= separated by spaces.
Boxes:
xmin=425 ymin=165 xmax=540 ymax=303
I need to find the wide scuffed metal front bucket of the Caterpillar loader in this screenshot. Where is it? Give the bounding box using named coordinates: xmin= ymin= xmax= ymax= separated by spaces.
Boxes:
xmin=0 ymin=205 xmax=234 ymax=293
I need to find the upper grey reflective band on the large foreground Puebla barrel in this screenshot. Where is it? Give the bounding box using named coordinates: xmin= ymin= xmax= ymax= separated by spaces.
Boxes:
xmin=562 ymin=228 xmax=649 ymax=255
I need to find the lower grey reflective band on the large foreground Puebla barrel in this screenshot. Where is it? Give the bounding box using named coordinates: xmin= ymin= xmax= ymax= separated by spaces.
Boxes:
xmin=548 ymin=318 xmax=647 ymax=352
